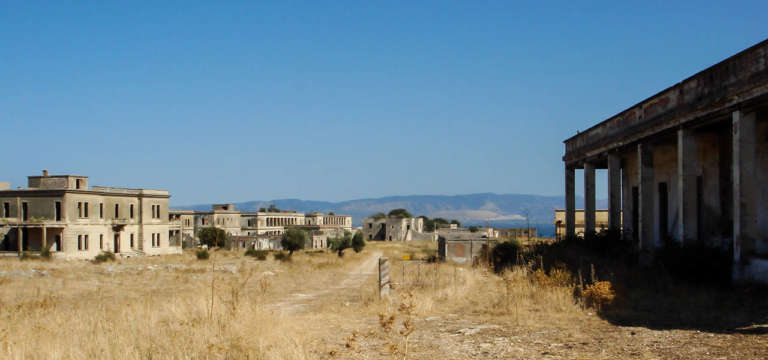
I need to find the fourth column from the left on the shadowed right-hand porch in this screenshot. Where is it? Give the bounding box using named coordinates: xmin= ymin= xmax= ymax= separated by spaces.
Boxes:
xmin=637 ymin=144 xmax=655 ymax=250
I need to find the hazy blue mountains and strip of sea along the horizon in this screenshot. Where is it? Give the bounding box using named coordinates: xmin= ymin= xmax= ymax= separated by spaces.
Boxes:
xmin=174 ymin=193 xmax=605 ymax=236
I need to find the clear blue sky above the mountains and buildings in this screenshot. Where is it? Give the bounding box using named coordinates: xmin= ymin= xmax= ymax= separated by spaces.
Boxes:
xmin=0 ymin=0 xmax=768 ymax=204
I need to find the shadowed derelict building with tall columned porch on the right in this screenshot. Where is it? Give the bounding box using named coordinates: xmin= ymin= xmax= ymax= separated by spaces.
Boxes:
xmin=563 ymin=40 xmax=768 ymax=282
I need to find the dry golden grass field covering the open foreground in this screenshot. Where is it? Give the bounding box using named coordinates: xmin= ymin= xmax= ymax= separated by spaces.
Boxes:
xmin=0 ymin=243 xmax=766 ymax=359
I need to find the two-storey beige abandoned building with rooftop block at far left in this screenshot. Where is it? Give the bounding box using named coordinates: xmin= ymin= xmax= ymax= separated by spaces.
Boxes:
xmin=0 ymin=170 xmax=181 ymax=259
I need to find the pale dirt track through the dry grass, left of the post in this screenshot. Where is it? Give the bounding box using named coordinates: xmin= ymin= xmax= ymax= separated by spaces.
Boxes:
xmin=271 ymin=252 xmax=382 ymax=315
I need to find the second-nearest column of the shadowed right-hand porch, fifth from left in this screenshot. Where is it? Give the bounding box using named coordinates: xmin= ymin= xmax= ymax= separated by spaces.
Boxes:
xmin=677 ymin=129 xmax=698 ymax=244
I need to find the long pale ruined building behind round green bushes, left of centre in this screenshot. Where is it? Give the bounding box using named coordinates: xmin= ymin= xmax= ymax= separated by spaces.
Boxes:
xmin=170 ymin=204 xmax=352 ymax=249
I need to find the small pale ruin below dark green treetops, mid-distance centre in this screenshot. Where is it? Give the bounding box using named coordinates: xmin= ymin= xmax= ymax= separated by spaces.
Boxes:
xmin=363 ymin=216 xmax=432 ymax=241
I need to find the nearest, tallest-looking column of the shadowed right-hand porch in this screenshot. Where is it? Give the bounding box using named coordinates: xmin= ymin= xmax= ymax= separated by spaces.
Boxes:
xmin=732 ymin=111 xmax=757 ymax=264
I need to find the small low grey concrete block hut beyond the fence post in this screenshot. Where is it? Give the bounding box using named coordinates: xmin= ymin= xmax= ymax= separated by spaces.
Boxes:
xmin=437 ymin=232 xmax=498 ymax=264
